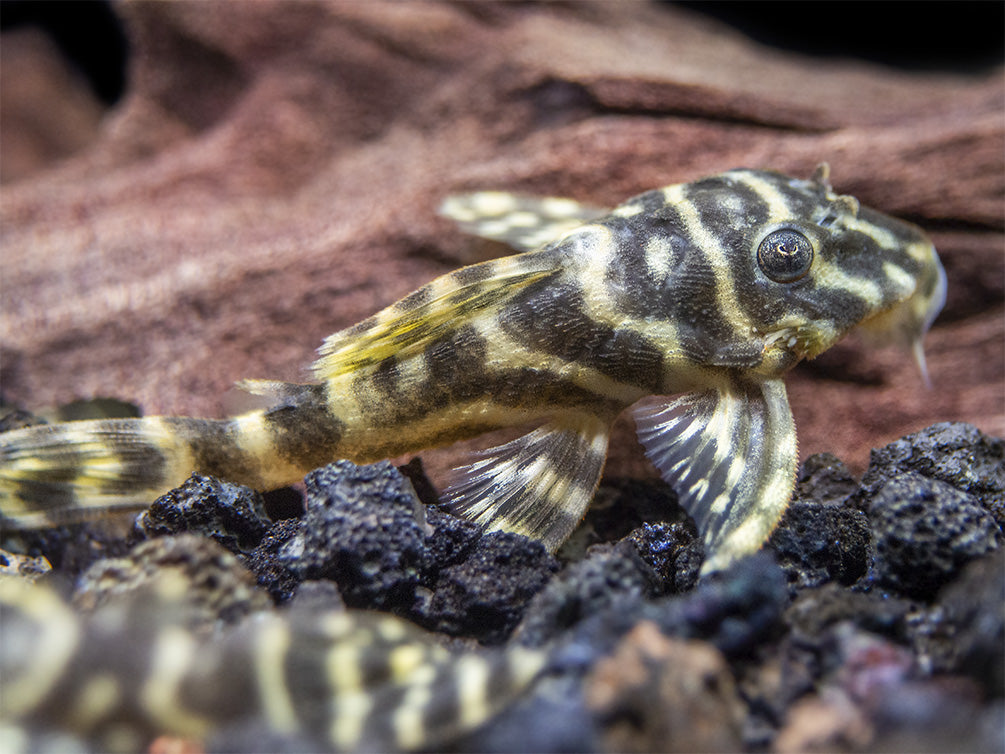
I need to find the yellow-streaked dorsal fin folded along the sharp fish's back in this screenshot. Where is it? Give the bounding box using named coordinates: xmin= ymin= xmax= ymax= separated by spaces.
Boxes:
xmin=312 ymin=263 xmax=559 ymax=380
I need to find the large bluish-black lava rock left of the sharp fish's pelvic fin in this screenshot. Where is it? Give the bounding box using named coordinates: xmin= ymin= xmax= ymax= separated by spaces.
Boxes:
xmin=279 ymin=460 xmax=425 ymax=609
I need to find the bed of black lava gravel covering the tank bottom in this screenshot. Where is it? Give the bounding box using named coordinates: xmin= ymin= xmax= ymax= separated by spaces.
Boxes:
xmin=0 ymin=423 xmax=1005 ymax=752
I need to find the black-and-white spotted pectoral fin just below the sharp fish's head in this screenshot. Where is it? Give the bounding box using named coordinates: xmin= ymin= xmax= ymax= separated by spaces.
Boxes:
xmin=633 ymin=380 xmax=798 ymax=573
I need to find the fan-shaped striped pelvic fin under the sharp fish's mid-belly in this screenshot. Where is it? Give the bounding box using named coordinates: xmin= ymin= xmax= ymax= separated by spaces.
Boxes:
xmin=441 ymin=414 xmax=608 ymax=552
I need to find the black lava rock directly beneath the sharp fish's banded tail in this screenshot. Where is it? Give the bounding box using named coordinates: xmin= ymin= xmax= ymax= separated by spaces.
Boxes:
xmin=134 ymin=474 xmax=272 ymax=553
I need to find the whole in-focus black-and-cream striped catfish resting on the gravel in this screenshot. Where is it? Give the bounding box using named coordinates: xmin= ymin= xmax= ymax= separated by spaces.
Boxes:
xmin=0 ymin=168 xmax=946 ymax=572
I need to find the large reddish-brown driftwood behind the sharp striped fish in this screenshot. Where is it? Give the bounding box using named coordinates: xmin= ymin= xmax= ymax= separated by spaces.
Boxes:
xmin=0 ymin=1 xmax=1005 ymax=484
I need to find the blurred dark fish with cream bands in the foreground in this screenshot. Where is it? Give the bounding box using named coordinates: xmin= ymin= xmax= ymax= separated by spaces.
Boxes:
xmin=0 ymin=568 xmax=548 ymax=752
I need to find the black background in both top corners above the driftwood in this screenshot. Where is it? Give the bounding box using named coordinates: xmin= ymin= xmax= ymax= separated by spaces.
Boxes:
xmin=0 ymin=0 xmax=1005 ymax=105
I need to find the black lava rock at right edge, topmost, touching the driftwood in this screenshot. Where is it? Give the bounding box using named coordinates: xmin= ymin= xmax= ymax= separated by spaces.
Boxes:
xmin=856 ymin=421 xmax=1005 ymax=528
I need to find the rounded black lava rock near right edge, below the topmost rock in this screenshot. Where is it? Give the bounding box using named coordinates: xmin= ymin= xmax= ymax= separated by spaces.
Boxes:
xmin=867 ymin=472 xmax=1001 ymax=601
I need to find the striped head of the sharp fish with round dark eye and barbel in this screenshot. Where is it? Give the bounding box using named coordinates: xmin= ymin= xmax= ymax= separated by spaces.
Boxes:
xmin=703 ymin=166 xmax=946 ymax=382
